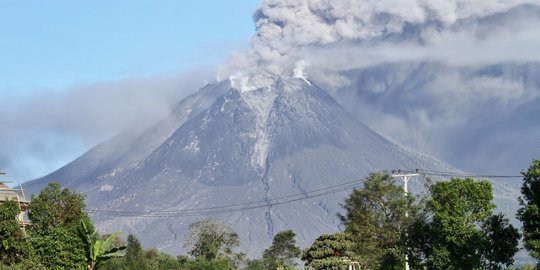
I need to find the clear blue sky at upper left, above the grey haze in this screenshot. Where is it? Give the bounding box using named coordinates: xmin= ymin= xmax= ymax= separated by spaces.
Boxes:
xmin=0 ymin=0 xmax=259 ymax=96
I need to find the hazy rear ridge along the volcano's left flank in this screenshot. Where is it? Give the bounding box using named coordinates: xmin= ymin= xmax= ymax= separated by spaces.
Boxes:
xmin=25 ymin=82 xmax=229 ymax=194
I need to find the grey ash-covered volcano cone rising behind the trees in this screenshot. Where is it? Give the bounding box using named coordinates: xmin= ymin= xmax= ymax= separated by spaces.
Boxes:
xmin=25 ymin=78 xmax=448 ymax=256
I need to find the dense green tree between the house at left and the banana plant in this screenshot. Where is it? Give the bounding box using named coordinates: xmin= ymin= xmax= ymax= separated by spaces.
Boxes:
xmin=28 ymin=183 xmax=94 ymax=269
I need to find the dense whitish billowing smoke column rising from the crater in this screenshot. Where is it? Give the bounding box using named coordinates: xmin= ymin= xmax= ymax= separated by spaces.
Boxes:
xmin=223 ymin=0 xmax=540 ymax=88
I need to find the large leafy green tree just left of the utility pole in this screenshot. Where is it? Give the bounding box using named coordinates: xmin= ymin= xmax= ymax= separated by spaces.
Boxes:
xmin=338 ymin=173 xmax=418 ymax=269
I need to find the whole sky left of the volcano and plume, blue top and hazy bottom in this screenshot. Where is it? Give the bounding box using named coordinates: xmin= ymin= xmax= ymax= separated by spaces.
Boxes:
xmin=0 ymin=0 xmax=260 ymax=181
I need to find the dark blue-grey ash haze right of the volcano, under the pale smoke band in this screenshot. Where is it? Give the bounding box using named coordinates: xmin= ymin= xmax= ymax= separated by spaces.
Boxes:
xmin=334 ymin=61 xmax=540 ymax=175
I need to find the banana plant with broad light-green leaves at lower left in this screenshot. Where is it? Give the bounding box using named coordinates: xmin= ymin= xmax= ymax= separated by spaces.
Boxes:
xmin=81 ymin=222 xmax=126 ymax=270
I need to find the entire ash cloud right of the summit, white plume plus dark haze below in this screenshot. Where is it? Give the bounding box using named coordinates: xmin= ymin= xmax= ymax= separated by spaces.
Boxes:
xmin=221 ymin=0 xmax=540 ymax=174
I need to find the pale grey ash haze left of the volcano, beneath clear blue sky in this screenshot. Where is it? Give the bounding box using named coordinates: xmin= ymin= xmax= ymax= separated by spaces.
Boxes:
xmin=0 ymin=68 xmax=215 ymax=181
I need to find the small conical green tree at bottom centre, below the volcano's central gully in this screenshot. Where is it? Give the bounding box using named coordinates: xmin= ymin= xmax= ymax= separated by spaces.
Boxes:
xmin=262 ymin=230 xmax=300 ymax=269
